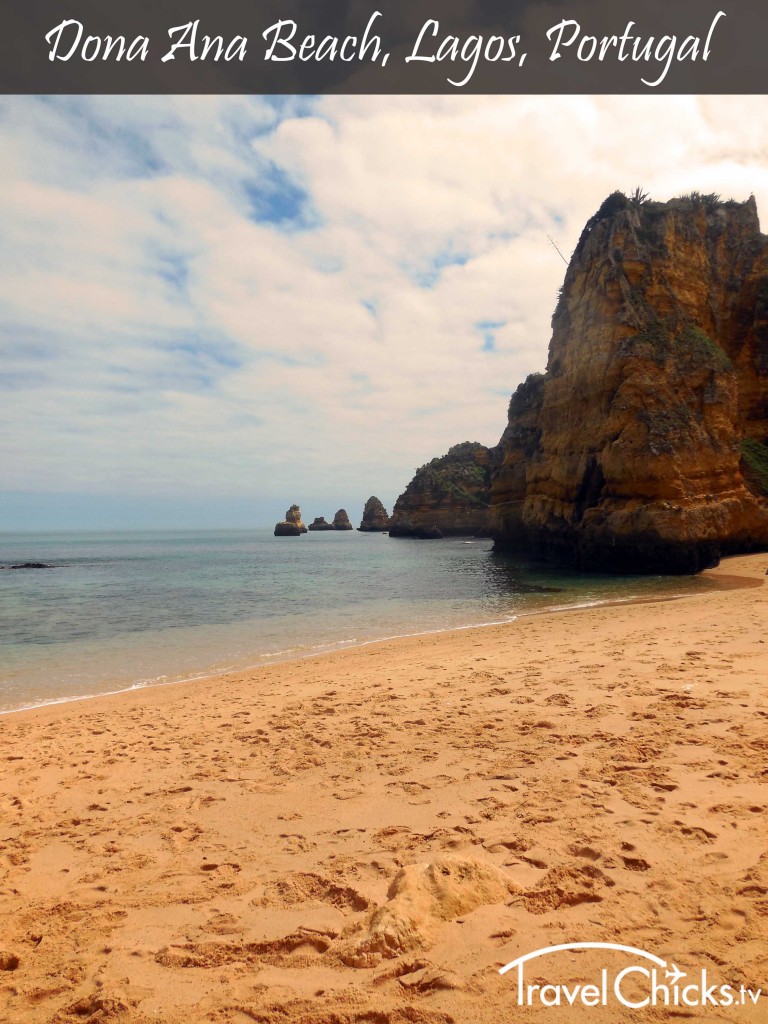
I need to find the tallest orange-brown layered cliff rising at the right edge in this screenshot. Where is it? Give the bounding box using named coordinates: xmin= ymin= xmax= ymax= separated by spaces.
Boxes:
xmin=490 ymin=193 xmax=768 ymax=572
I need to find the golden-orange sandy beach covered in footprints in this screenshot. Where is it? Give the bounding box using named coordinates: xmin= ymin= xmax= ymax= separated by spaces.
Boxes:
xmin=0 ymin=555 xmax=768 ymax=1024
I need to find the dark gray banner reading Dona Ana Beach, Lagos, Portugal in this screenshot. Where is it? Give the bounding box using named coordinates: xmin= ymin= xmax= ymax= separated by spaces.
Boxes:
xmin=0 ymin=0 xmax=768 ymax=94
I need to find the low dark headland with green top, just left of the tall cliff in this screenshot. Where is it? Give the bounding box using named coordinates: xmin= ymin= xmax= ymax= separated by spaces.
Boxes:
xmin=389 ymin=441 xmax=497 ymax=540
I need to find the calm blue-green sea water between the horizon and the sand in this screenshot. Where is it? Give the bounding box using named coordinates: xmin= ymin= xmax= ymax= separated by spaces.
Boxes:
xmin=0 ymin=529 xmax=714 ymax=712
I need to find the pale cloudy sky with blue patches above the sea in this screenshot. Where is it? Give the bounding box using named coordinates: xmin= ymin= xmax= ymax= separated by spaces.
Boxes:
xmin=0 ymin=95 xmax=768 ymax=530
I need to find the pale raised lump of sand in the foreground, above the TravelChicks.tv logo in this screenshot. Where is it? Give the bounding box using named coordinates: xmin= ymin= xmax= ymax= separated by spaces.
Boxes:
xmin=341 ymin=856 xmax=517 ymax=968
